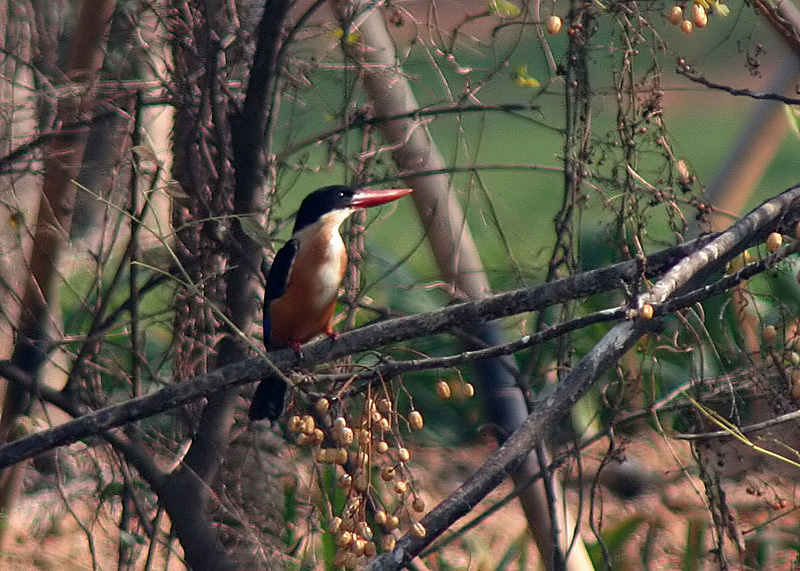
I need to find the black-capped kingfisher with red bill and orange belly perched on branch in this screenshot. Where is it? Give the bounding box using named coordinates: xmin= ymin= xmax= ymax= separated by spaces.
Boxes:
xmin=248 ymin=185 xmax=412 ymax=421
